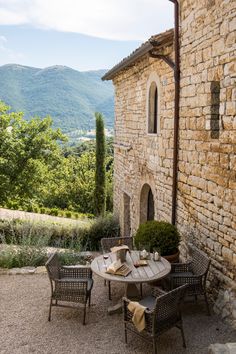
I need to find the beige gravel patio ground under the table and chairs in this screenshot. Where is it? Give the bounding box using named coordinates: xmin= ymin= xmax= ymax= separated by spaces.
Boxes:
xmin=0 ymin=274 xmax=236 ymax=354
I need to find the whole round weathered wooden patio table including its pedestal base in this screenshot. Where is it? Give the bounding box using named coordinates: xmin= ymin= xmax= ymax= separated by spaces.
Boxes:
xmin=91 ymin=251 xmax=171 ymax=313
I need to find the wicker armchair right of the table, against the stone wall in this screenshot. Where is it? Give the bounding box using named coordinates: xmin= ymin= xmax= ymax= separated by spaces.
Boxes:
xmin=169 ymin=248 xmax=211 ymax=315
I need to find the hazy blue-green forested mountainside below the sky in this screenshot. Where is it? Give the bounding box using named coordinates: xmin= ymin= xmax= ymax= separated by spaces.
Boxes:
xmin=0 ymin=64 xmax=114 ymax=133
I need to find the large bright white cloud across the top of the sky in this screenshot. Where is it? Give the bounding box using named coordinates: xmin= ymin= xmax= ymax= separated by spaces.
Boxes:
xmin=0 ymin=0 xmax=173 ymax=40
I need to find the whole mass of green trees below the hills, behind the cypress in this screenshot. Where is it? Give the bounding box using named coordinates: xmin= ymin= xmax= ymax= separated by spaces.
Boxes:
xmin=0 ymin=102 xmax=113 ymax=214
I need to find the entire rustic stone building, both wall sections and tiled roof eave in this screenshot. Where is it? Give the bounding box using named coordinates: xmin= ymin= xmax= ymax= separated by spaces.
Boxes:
xmin=104 ymin=0 xmax=236 ymax=326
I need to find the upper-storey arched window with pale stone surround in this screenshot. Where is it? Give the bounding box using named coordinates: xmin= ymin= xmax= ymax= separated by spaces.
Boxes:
xmin=147 ymin=73 xmax=160 ymax=134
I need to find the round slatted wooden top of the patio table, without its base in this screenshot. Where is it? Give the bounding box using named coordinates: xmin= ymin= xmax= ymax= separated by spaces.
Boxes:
xmin=91 ymin=251 xmax=171 ymax=283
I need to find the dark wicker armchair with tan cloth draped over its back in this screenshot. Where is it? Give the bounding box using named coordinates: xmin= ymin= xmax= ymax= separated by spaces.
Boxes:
xmin=123 ymin=284 xmax=187 ymax=354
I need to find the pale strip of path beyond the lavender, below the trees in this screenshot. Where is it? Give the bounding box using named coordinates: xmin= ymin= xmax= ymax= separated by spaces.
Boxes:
xmin=0 ymin=208 xmax=89 ymax=226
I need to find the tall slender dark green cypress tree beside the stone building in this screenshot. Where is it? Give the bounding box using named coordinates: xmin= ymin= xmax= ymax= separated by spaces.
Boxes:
xmin=94 ymin=112 xmax=106 ymax=216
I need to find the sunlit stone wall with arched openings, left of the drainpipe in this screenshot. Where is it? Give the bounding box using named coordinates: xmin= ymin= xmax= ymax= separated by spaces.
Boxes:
xmin=114 ymin=48 xmax=174 ymax=234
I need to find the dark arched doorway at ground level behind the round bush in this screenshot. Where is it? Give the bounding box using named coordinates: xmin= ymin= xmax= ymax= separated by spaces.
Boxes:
xmin=140 ymin=183 xmax=155 ymax=224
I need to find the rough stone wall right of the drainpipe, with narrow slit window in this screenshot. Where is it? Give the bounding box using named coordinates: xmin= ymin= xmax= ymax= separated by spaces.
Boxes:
xmin=177 ymin=0 xmax=236 ymax=325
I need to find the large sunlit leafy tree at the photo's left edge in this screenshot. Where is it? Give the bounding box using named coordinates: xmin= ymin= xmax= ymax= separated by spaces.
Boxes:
xmin=0 ymin=102 xmax=66 ymax=203
